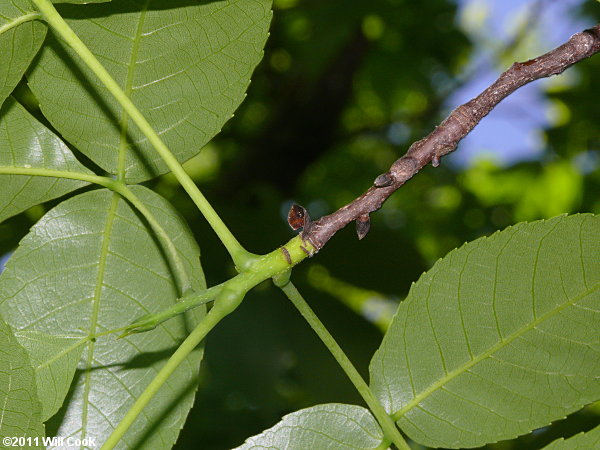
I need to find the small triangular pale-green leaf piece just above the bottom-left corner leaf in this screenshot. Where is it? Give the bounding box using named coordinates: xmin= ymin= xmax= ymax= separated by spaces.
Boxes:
xmin=17 ymin=331 xmax=84 ymax=422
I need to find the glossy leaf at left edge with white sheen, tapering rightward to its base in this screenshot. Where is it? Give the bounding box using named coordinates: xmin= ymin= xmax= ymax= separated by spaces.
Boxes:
xmin=0 ymin=98 xmax=91 ymax=222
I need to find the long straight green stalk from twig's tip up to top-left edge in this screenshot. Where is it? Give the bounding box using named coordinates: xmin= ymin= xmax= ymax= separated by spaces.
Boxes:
xmin=33 ymin=0 xmax=255 ymax=270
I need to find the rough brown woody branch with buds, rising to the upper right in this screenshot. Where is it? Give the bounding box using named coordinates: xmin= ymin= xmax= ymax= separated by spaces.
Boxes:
xmin=302 ymin=24 xmax=600 ymax=250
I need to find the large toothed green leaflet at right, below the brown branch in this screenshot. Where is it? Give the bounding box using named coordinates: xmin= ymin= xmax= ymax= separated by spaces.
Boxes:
xmin=370 ymin=214 xmax=600 ymax=448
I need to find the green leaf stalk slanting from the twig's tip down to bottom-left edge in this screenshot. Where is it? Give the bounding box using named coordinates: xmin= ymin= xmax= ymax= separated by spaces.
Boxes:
xmin=101 ymin=293 xmax=243 ymax=450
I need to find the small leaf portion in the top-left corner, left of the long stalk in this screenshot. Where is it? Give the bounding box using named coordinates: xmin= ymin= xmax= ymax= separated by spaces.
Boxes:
xmin=0 ymin=0 xmax=46 ymax=106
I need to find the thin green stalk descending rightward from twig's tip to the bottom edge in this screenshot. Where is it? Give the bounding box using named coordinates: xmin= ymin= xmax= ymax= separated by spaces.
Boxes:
xmin=279 ymin=282 xmax=410 ymax=450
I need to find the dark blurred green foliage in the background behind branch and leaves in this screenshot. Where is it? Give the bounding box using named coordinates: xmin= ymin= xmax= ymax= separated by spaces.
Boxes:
xmin=0 ymin=0 xmax=600 ymax=449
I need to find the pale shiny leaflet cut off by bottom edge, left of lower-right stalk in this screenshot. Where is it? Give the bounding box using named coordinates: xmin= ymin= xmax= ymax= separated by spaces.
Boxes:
xmin=238 ymin=403 xmax=383 ymax=450
